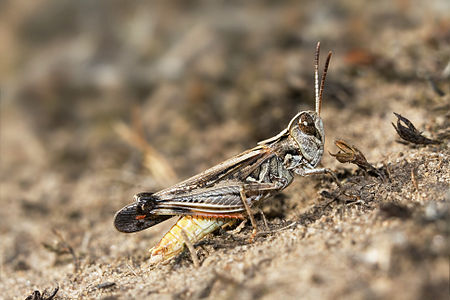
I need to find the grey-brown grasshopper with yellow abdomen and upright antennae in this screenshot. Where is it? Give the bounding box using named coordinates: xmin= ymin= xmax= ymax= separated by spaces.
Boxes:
xmin=114 ymin=42 xmax=335 ymax=263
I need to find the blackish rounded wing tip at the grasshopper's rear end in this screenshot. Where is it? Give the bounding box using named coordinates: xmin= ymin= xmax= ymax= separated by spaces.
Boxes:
xmin=114 ymin=203 xmax=172 ymax=233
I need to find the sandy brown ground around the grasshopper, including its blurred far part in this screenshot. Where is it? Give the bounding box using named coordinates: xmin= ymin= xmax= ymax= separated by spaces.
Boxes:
xmin=0 ymin=0 xmax=450 ymax=299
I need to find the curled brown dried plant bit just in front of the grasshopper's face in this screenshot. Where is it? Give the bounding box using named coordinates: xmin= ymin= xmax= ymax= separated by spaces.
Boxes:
xmin=329 ymin=140 xmax=384 ymax=179
